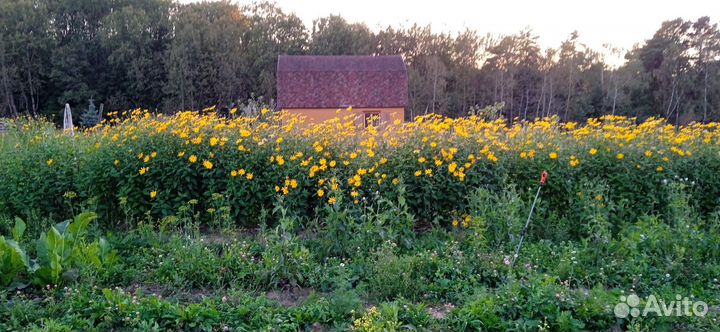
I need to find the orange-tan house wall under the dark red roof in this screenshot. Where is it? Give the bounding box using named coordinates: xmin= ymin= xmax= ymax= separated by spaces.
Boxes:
xmin=284 ymin=107 xmax=405 ymax=126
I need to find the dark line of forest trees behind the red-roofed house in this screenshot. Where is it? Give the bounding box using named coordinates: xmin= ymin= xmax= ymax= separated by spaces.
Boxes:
xmin=0 ymin=0 xmax=720 ymax=123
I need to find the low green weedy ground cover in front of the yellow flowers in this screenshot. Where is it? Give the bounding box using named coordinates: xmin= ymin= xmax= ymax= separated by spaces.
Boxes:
xmin=0 ymin=188 xmax=720 ymax=331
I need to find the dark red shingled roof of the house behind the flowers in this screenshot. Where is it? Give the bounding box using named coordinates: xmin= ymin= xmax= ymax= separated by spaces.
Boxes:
xmin=277 ymin=55 xmax=408 ymax=109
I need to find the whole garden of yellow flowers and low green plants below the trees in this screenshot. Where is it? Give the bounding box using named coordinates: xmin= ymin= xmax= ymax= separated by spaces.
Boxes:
xmin=0 ymin=108 xmax=720 ymax=331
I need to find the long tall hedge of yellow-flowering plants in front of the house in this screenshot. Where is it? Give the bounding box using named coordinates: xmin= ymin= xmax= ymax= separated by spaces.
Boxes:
xmin=0 ymin=110 xmax=720 ymax=231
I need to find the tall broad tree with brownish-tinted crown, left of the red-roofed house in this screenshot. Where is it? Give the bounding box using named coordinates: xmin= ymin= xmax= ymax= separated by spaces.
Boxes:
xmin=164 ymin=1 xmax=248 ymax=110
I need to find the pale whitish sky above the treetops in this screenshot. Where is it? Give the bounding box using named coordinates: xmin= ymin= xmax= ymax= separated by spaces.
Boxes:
xmin=181 ymin=0 xmax=720 ymax=65
